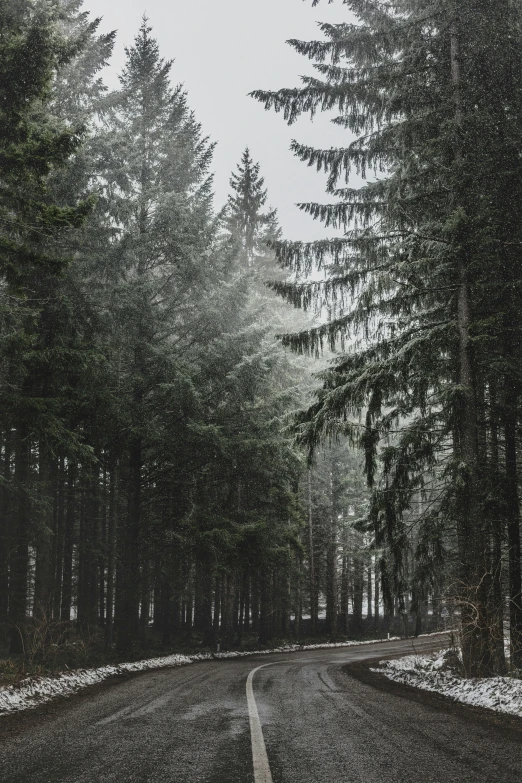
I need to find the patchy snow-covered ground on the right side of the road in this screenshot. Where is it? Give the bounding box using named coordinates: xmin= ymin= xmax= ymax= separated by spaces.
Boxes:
xmin=372 ymin=651 xmax=522 ymax=717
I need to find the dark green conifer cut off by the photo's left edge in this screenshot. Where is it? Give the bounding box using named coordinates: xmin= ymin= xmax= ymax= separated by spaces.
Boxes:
xmin=0 ymin=1 xmax=91 ymax=652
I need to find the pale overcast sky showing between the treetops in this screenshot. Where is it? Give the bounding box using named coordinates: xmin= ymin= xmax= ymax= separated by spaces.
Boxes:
xmin=84 ymin=0 xmax=358 ymax=240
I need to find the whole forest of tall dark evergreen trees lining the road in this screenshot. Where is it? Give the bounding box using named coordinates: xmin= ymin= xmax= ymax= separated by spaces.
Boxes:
xmin=0 ymin=0 xmax=522 ymax=676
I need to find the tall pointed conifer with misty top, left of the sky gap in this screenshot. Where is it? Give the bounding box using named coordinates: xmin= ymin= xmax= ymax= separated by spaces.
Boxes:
xmin=96 ymin=19 xmax=213 ymax=650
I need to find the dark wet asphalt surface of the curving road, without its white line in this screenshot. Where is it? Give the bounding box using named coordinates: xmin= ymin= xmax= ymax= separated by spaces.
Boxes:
xmin=0 ymin=639 xmax=522 ymax=783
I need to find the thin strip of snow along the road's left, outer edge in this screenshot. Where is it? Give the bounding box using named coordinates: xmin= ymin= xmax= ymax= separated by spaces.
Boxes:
xmin=0 ymin=634 xmax=438 ymax=717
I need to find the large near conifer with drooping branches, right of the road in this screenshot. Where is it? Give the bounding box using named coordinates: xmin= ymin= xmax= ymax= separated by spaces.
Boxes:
xmin=254 ymin=0 xmax=522 ymax=676
